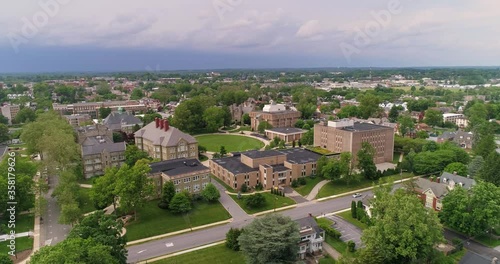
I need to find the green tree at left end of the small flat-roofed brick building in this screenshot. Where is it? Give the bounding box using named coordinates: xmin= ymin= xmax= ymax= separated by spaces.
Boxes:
xmin=115 ymin=159 xmax=153 ymax=219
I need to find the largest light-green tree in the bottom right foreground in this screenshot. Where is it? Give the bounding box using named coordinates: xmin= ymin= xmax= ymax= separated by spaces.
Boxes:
xmin=361 ymin=190 xmax=443 ymax=263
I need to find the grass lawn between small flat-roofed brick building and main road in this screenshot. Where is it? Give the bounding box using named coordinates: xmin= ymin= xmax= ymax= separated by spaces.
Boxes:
xmin=126 ymin=200 xmax=231 ymax=241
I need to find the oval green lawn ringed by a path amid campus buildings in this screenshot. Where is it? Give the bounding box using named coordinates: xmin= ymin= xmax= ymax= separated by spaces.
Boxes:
xmin=196 ymin=134 xmax=264 ymax=152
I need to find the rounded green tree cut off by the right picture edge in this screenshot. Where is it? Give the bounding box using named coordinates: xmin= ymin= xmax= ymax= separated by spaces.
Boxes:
xmin=439 ymin=182 xmax=500 ymax=237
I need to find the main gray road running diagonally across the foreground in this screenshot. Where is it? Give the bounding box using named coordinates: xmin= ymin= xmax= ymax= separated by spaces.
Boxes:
xmin=128 ymin=189 xmax=376 ymax=263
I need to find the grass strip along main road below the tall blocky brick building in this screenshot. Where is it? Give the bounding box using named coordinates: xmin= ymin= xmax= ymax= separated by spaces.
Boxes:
xmin=316 ymin=172 xmax=414 ymax=198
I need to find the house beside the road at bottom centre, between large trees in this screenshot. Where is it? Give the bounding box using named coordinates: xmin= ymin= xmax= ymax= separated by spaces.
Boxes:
xmin=295 ymin=216 xmax=325 ymax=259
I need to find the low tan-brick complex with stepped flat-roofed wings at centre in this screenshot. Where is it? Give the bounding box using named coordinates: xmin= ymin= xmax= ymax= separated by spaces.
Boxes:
xmin=209 ymin=148 xmax=320 ymax=190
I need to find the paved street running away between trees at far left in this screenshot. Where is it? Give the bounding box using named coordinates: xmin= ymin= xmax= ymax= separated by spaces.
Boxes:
xmin=40 ymin=173 xmax=71 ymax=247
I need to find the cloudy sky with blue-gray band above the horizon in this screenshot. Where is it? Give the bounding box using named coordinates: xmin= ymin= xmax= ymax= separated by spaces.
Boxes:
xmin=0 ymin=0 xmax=500 ymax=72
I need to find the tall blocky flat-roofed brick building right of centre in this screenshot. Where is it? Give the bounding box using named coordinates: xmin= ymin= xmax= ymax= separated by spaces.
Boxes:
xmin=314 ymin=119 xmax=394 ymax=163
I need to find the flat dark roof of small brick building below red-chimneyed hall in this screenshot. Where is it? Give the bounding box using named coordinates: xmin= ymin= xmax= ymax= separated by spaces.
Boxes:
xmin=149 ymin=158 xmax=209 ymax=177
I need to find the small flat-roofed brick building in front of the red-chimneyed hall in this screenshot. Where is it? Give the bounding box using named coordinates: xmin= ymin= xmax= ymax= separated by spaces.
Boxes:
xmin=149 ymin=158 xmax=210 ymax=196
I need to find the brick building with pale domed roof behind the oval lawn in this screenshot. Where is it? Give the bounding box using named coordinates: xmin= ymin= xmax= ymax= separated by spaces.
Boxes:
xmin=249 ymin=101 xmax=301 ymax=131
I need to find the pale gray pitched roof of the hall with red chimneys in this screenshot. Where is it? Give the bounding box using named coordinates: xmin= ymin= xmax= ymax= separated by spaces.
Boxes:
xmin=134 ymin=121 xmax=198 ymax=147
